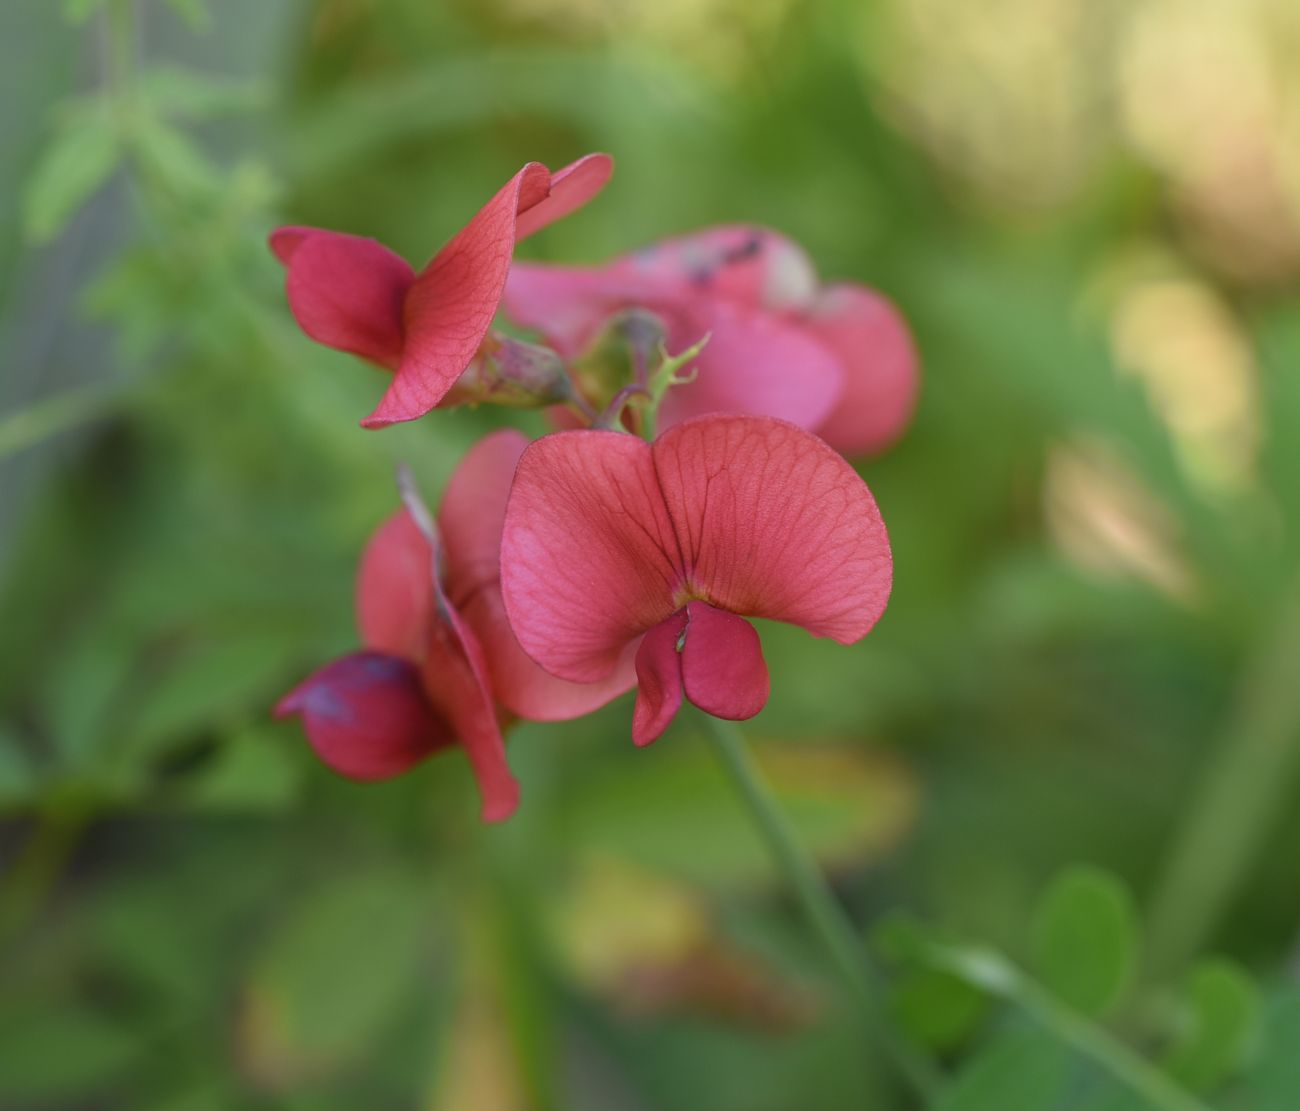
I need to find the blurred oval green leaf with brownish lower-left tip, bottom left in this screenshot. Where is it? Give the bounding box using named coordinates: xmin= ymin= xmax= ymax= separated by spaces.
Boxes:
xmin=239 ymin=871 xmax=430 ymax=1088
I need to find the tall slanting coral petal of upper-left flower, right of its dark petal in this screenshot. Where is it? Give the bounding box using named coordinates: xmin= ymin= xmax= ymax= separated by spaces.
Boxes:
xmin=361 ymin=162 xmax=550 ymax=428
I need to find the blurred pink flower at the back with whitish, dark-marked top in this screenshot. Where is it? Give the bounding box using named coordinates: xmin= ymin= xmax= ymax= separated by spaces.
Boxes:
xmin=503 ymin=225 xmax=918 ymax=455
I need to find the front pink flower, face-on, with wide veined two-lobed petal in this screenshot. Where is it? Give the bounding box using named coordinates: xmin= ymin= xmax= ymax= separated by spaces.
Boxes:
xmin=501 ymin=416 xmax=892 ymax=745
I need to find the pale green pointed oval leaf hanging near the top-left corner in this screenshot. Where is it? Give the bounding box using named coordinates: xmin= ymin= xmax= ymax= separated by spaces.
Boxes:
xmin=22 ymin=100 xmax=121 ymax=243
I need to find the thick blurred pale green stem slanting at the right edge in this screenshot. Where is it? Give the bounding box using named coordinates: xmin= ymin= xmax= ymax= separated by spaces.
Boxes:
xmin=1148 ymin=585 xmax=1300 ymax=978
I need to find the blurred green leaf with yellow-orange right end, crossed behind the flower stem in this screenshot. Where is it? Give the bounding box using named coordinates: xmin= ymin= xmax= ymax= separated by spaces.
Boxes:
xmin=562 ymin=730 xmax=915 ymax=885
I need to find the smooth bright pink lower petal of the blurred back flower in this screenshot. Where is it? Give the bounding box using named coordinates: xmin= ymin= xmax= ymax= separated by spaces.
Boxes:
xmin=659 ymin=301 xmax=844 ymax=429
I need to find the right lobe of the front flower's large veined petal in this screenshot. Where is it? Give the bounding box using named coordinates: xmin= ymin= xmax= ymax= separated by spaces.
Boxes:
xmin=655 ymin=416 xmax=893 ymax=641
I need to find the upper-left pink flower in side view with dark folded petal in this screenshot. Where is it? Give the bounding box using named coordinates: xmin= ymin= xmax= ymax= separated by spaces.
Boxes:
xmin=270 ymin=155 xmax=614 ymax=428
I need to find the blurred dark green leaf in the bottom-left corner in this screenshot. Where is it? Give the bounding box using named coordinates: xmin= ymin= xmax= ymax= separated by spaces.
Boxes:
xmin=0 ymin=1010 xmax=148 ymax=1106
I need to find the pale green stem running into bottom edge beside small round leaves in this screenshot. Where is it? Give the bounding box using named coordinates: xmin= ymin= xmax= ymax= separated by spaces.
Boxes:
xmin=926 ymin=943 xmax=1210 ymax=1111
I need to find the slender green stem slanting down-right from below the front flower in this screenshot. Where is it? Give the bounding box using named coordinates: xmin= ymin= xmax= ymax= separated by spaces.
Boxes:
xmin=705 ymin=715 xmax=941 ymax=1101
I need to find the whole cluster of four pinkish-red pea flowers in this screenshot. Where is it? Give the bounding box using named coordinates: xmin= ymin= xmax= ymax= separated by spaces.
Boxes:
xmin=270 ymin=155 xmax=917 ymax=820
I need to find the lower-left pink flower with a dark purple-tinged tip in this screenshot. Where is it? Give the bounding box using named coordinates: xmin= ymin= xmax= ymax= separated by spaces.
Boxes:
xmin=276 ymin=431 xmax=633 ymax=821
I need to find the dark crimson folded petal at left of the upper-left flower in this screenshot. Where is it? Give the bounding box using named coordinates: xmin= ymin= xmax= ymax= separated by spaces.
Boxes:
xmin=270 ymin=227 xmax=415 ymax=370
